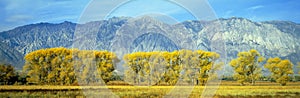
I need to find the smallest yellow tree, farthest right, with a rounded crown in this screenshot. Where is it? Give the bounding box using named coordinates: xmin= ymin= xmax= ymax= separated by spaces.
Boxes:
xmin=264 ymin=57 xmax=294 ymax=86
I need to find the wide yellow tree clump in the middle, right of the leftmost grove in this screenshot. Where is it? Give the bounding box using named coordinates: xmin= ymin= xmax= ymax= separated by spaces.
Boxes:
xmin=124 ymin=50 xmax=222 ymax=85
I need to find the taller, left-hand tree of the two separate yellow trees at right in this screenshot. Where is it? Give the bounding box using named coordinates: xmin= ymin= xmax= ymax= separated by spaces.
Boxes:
xmin=230 ymin=49 xmax=264 ymax=85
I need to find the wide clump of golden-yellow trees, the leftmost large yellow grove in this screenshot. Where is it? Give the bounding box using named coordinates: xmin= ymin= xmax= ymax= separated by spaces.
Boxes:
xmin=23 ymin=48 xmax=119 ymax=85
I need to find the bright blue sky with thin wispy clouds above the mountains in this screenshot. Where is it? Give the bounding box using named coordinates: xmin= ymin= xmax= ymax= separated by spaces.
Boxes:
xmin=0 ymin=0 xmax=300 ymax=31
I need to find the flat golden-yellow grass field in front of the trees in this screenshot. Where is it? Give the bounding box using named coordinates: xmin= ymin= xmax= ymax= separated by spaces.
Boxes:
xmin=0 ymin=82 xmax=300 ymax=98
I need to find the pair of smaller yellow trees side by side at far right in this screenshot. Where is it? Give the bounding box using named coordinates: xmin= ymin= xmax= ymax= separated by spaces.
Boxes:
xmin=230 ymin=50 xmax=294 ymax=86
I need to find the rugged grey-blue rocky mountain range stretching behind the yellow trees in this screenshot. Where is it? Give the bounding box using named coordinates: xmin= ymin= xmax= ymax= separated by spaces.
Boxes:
xmin=0 ymin=16 xmax=300 ymax=69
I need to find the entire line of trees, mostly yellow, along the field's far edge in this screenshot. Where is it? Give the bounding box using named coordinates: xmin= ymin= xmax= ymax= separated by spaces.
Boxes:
xmin=0 ymin=48 xmax=300 ymax=85
